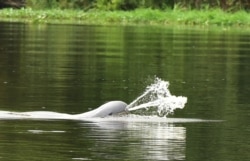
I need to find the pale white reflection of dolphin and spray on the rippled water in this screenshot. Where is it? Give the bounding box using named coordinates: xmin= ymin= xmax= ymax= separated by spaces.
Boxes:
xmin=89 ymin=121 xmax=186 ymax=160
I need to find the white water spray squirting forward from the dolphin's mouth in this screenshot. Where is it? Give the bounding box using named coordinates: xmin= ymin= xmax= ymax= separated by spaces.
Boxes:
xmin=127 ymin=78 xmax=187 ymax=116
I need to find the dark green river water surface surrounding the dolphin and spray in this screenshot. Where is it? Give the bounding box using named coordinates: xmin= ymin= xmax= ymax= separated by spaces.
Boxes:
xmin=0 ymin=23 xmax=250 ymax=161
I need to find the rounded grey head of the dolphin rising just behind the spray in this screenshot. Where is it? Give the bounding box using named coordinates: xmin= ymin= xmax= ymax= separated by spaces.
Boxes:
xmin=75 ymin=101 xmax=127 ymax=118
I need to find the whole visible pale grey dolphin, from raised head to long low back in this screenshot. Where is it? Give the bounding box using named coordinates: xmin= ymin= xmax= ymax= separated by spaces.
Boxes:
xmin=0 ymin=101 xmax=127 ymax=120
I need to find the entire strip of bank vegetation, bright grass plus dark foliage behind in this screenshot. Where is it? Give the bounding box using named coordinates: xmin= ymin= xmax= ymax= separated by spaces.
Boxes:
xmin=0 ymin=0 xmax=250 ymax=27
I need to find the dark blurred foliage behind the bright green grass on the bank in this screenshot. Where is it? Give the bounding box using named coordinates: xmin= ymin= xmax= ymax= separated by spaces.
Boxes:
xmin=21 ymin=0 xmax=250 ymax=11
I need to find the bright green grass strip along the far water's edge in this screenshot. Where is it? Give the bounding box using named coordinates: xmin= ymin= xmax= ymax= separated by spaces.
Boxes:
xmin=0 ymin=9 xmax=250 ymax=27
